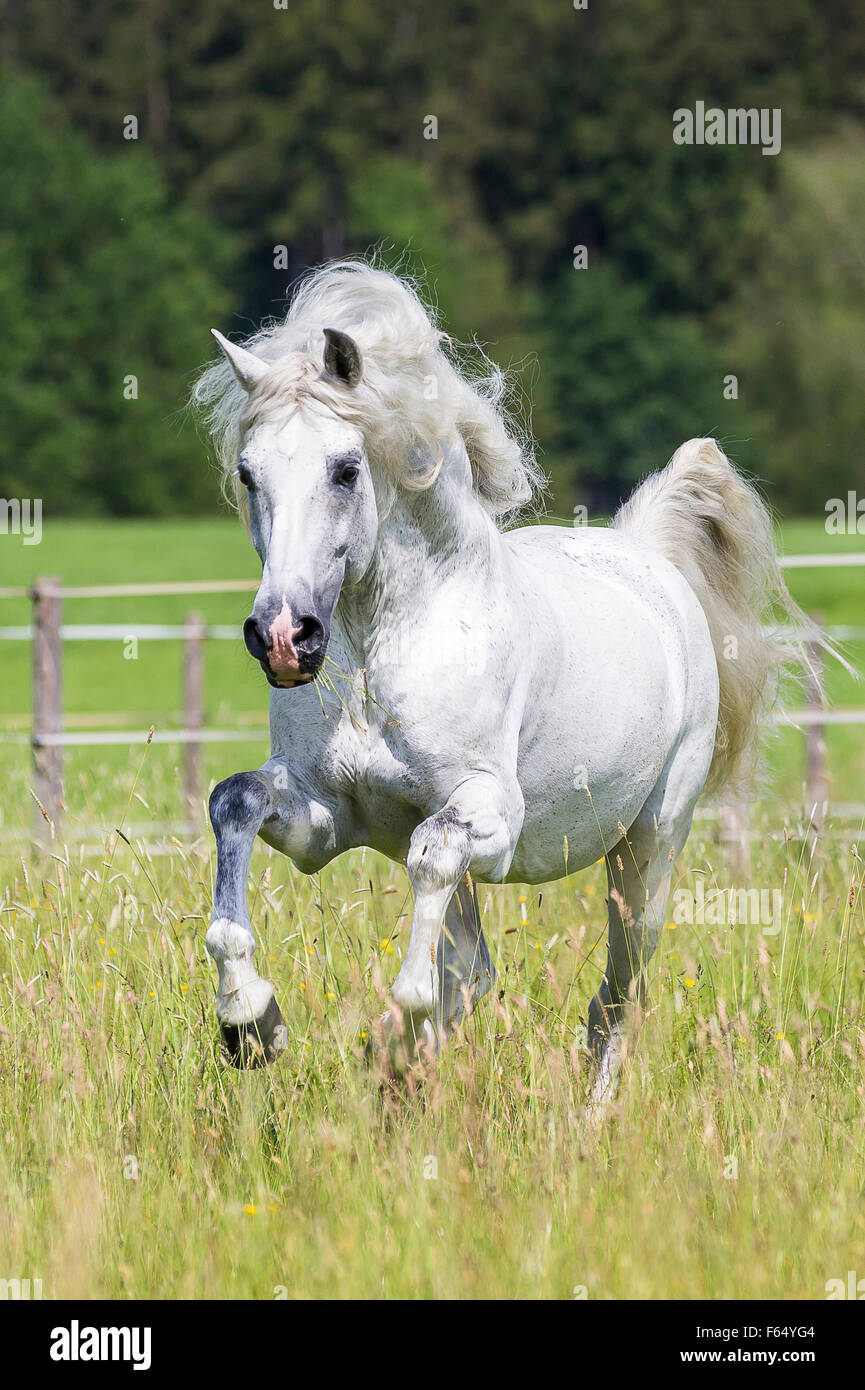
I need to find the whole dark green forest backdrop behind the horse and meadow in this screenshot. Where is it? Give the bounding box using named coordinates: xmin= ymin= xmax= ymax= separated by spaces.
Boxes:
xmin=0 ymin=0 xmax=865 ymax=514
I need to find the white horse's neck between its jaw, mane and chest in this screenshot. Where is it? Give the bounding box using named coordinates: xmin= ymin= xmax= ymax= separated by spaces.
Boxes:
xmin=337 ymin=471 xmax=502 ymax=663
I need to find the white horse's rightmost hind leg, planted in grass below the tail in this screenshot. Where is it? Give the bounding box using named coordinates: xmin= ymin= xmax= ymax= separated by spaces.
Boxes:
xmin=588 ymin=737 xmax=711 ymax=1118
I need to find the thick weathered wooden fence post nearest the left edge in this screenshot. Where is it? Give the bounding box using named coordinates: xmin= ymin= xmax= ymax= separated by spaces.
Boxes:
xmin=31 ymin=577 xmax=63 ymax=844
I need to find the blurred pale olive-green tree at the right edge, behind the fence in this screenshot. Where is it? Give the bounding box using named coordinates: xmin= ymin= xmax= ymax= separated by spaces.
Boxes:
xmin=725 ymin=126 xmax=865 ymax=516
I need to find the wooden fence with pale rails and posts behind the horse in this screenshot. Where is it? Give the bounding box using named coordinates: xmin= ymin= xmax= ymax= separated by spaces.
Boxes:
xmin=0 ymin=552 xmax=865 ymax=847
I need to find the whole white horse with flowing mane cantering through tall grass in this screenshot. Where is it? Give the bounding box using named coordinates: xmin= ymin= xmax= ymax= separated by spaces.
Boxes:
xmin=196 ymin=263 xmax=801 ymax=1098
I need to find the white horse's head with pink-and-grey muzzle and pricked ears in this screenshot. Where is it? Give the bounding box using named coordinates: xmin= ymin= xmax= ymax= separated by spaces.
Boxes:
xmin=214 ymin=328 xmax=378 ymax=687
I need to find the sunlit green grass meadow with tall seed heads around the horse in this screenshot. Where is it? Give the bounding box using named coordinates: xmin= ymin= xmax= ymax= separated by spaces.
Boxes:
xmin=0 ymin=520 xmax=865 ymax=1300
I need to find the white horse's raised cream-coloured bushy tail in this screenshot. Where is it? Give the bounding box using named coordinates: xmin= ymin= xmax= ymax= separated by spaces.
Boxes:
xmin=612 ymin=439 xmax=829 ymax=791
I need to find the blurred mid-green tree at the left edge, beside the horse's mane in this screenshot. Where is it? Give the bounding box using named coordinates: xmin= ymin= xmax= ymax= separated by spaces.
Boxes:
xmin=0 ymin=75 xmax=232 ymax=514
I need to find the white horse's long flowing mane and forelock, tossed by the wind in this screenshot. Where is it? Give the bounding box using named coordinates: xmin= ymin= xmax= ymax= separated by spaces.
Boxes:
xmin=192 ymin=260 xmax=544 ymax=518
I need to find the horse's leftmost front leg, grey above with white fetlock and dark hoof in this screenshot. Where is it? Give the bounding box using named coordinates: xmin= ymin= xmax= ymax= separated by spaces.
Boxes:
xmin=204 ymin=771 xmax=288 ymax=1066
